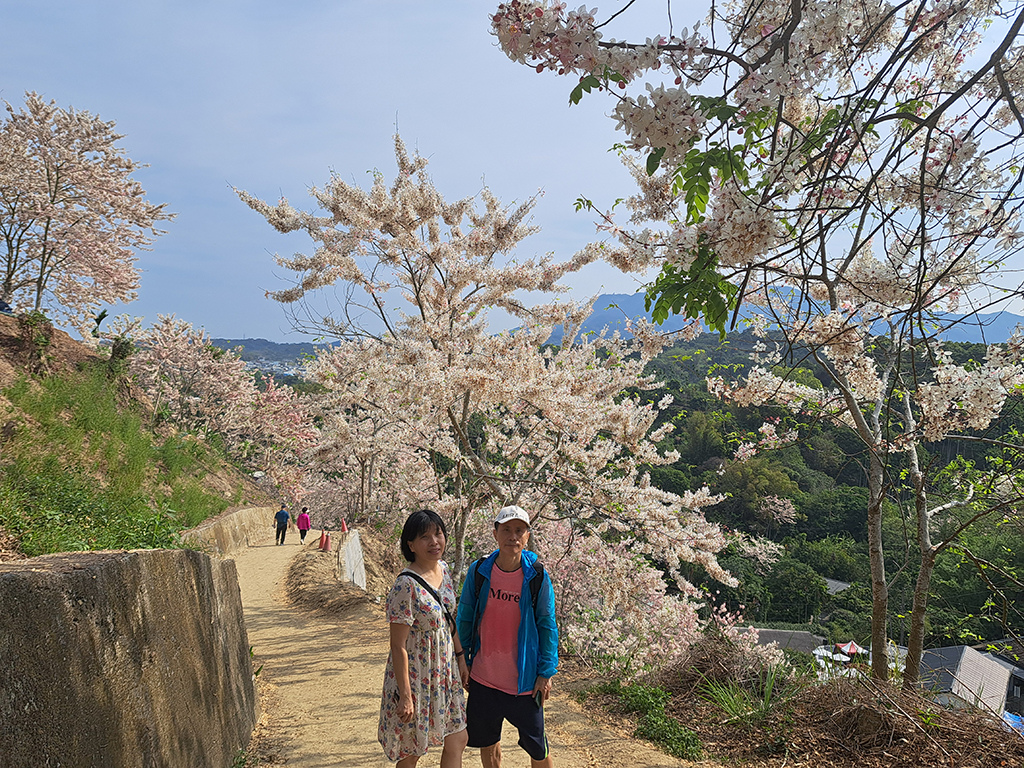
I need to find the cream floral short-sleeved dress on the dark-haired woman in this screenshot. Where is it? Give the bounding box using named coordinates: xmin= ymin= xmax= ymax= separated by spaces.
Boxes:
xmin=377 ymin=562 xmax=466 ymax=762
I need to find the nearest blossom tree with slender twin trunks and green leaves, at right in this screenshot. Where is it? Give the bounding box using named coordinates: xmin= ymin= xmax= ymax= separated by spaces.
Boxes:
xmin=493 ymin=0 xmax=1024 ymax=684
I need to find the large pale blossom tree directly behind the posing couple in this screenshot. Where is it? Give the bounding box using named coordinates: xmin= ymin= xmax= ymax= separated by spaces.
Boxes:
xmin=239 ymin=137 xmax=731 ymax=663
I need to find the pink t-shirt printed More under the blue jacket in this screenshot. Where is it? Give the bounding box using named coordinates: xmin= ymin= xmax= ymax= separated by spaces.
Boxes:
xmin=470 ymin=563 xmax=522 ymax=696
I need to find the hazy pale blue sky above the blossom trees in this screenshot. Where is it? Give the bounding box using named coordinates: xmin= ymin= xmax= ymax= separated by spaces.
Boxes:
xmin=0 ymin=0 xmax=688 ymax=341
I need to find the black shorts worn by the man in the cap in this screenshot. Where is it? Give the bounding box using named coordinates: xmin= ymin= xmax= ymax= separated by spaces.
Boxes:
xmin=466 ymin=679 xmax=548 ymax=760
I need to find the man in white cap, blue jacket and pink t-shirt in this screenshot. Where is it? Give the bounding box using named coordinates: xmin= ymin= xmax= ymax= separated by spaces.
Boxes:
xmin=457 ymin=506 xmax=558 ymax=768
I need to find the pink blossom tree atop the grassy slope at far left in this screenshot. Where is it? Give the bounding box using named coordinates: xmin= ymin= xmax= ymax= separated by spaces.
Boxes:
xmin=0 ymin=92 xmax=172 ymax=338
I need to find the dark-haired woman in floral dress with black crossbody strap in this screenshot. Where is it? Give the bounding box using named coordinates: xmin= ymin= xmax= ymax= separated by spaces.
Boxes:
xmin=377 ymin=509 xmax=469 ymax=768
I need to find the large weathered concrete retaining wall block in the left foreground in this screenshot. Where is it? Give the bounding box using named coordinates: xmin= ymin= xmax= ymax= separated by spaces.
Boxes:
xmin=0 ymin=548 xmax=256 ymax=768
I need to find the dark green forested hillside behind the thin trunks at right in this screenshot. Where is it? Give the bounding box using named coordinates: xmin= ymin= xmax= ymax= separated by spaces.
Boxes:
xmin=643 ymin=333 xmax=1024 ymax=646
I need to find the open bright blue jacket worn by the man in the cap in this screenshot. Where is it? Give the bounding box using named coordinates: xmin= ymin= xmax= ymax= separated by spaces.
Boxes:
xmin=456 ymin=551 xmax=558 ymax=693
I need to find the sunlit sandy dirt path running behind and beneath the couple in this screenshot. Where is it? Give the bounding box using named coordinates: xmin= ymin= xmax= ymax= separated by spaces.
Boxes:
xmin=234 ymin=536 xmax=694 ymax=768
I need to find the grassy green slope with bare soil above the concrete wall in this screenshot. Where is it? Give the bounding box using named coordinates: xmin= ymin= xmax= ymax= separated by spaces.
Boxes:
xmin=0 ymin=316 xmax=268 ymax=559
